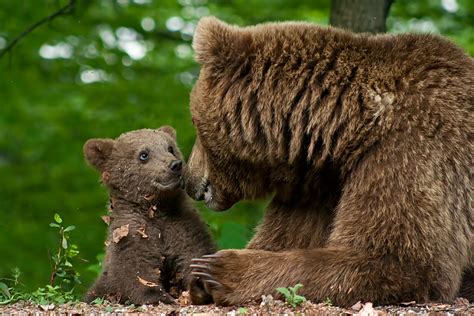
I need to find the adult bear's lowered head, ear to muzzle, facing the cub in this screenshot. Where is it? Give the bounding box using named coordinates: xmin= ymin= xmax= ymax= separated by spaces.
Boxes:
xmin=186 ymin=17 xmax=278 ymax=210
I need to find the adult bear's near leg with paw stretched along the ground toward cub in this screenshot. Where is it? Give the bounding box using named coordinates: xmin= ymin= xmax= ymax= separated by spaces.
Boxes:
xmin=193 ymin=144 xmax=472 ymax=306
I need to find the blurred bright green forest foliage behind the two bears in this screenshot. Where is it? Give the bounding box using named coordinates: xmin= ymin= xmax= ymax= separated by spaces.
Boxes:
xmin=0 ymin=0 xmax=474 ymax=296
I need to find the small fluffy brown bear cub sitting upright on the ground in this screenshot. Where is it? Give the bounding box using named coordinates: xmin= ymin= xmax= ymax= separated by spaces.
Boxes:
xmin=84 ymin=126 xmax=215 ymax=304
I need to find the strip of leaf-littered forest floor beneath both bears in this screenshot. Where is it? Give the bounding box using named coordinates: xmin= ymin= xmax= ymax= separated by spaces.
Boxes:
xmin=0 ymin=296 xmax=474 ymax=315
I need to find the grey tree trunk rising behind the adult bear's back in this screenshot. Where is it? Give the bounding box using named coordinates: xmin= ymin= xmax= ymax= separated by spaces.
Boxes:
xmin=330 ymin=0 xmax=394 ymax=33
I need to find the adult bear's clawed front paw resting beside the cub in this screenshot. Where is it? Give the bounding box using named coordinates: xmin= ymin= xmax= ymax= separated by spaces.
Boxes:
xmin=191 ymin=250 xmax=250 ymax=305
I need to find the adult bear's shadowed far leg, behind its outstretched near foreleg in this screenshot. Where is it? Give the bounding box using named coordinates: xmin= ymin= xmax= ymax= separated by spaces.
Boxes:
xmin=247 ymin=201 xmax=334 ymax=251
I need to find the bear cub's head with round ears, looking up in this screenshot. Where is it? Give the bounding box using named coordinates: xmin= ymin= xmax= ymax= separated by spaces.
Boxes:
xmin=84 ymin=126 xmax=184 ymax=204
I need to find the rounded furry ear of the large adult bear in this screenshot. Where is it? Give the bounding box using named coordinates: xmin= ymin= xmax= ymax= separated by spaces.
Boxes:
xmin=193 ymin=16 xmax=252 ymax=67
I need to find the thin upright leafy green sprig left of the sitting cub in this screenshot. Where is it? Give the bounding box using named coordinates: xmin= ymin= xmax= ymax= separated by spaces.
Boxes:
xmin=49 ymin=214 xmax=81 ymax=291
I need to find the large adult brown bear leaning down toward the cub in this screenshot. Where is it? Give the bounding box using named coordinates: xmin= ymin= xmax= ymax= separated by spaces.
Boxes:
xmin=186 ymin=17 xmax=474 ymax=306
